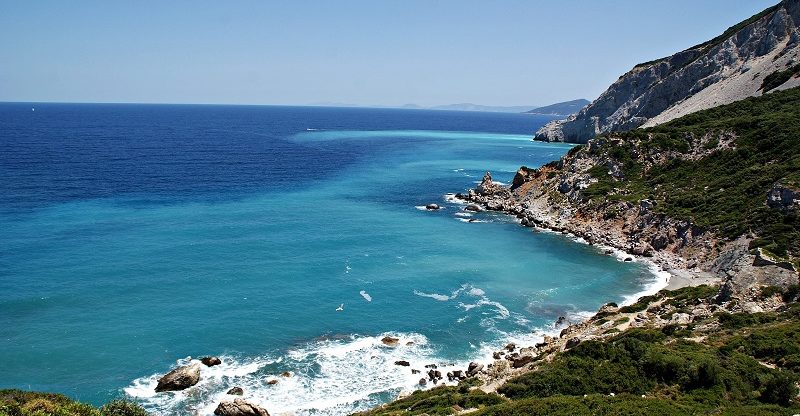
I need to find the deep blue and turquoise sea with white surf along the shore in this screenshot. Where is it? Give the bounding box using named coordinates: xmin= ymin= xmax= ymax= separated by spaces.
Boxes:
xmin=0 ymin=103 xmax=654 ymax=415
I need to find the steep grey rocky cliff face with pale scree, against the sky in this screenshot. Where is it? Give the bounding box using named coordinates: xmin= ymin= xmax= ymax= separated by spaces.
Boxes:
xmin=535 ymin=0 xmax=800 ymax=143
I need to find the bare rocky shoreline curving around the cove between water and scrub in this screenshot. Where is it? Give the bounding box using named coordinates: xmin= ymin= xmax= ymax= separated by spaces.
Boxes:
xmin=416 ymin=167 xmax=796 ymax=397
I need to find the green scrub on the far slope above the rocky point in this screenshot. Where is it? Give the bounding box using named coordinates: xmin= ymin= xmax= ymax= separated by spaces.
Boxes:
xmin=583 ymin=88 xmax=800 ymax=257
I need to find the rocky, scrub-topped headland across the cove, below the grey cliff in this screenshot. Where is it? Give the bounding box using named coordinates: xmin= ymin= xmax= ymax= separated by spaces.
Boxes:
xmin=468 ymin=88 xmax=800 ymax=305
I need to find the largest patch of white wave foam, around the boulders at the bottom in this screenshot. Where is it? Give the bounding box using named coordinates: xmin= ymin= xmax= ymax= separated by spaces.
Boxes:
xmin=125 ymin=333 xmax=468 ymax=415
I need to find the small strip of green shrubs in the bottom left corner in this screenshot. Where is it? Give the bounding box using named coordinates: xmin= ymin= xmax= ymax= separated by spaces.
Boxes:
xmin=0 ymin=390 xmax=147 ymax=416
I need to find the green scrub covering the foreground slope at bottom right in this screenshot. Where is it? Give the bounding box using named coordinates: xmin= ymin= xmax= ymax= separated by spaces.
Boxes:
xmin=358 ymin=292 xmax=800 ymax=416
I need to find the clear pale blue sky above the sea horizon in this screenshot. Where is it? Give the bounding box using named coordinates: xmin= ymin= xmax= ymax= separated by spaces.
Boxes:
xmin=0 ymin=0 xmax=778 ymax=105
